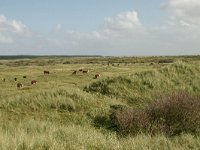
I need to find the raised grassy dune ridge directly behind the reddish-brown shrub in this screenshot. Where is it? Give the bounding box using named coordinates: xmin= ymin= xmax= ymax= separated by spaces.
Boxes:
xmin=84 ymin=62 xmax=200 ymax=106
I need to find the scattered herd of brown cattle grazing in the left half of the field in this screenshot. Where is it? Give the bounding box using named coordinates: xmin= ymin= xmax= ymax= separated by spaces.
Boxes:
xmin=2 ymin=69 xmax=100 ymax=89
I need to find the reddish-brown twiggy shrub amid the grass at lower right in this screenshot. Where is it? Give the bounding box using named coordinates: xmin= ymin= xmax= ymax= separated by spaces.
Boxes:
xmin=112 ymin=91 xmax=200 ymax=136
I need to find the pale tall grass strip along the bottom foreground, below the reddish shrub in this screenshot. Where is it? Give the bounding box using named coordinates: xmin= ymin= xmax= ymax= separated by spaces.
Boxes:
xmin=0 ymin=119 xmax=200 ymax=150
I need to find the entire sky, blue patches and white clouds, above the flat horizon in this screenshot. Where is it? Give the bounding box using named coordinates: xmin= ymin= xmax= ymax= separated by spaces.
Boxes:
xmin=0 ymin=0 xmax=200 ymax=56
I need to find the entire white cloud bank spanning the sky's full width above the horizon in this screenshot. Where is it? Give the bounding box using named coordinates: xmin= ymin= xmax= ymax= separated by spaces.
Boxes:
xmin=0 ymin=6 xmax=200 ymax=55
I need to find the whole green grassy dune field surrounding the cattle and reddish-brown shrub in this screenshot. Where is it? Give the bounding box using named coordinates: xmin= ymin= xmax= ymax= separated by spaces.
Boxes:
xmin=0 ymin=56 xmax=200 ymax=150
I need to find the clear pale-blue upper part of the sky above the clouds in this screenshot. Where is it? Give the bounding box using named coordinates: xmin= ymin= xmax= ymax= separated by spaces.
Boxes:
xmin=0 ymin=0 xmax=166 ymax=31
